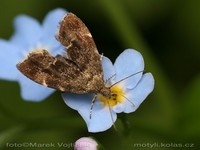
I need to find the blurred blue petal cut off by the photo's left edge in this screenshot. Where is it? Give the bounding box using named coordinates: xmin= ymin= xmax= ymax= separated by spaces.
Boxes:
xmin=0 ymin=40 xmax=20 ymax=80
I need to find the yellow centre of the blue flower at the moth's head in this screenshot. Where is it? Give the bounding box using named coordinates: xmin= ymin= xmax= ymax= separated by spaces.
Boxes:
xmin=99 ymin=86 xmax=124 ymax=106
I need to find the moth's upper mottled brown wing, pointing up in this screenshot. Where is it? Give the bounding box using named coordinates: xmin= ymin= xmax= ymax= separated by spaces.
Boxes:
xmin=56 ymin=13 xmax=102 ymax=70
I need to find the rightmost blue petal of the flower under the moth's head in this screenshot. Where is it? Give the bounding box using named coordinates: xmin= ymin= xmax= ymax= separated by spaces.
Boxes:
xmin=123 ymin=73 xmax=154 ymax=113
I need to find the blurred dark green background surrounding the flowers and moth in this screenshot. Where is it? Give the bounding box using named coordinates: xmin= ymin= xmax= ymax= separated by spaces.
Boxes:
xmin=0 ymin=0 xmax=200 ymax=150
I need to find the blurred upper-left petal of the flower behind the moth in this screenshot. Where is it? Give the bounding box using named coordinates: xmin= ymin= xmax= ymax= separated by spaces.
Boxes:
xmin=10 ymin=15 xmax=42 ymax=50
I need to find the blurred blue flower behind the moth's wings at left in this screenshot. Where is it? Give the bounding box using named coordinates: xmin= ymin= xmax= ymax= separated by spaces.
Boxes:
xmin=0 ymin=8 xmax=66 ymax=101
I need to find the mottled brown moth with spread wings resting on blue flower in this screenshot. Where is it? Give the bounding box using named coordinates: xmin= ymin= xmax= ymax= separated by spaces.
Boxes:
xmin=17 ymin=13 xmax=111 ymax=97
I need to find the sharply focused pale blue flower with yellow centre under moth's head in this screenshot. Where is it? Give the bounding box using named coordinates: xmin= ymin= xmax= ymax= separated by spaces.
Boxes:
xmin=63 ymin=49 xmax=154 ymax=132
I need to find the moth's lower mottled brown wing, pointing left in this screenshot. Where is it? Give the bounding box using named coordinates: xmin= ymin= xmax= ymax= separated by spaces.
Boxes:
xmin=17 ymin=50 xmax=101 ymax=94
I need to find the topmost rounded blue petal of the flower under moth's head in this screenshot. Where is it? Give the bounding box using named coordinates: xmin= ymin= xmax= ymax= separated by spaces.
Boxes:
xmin=114 ymin=49 xmax=144 ymax=88
